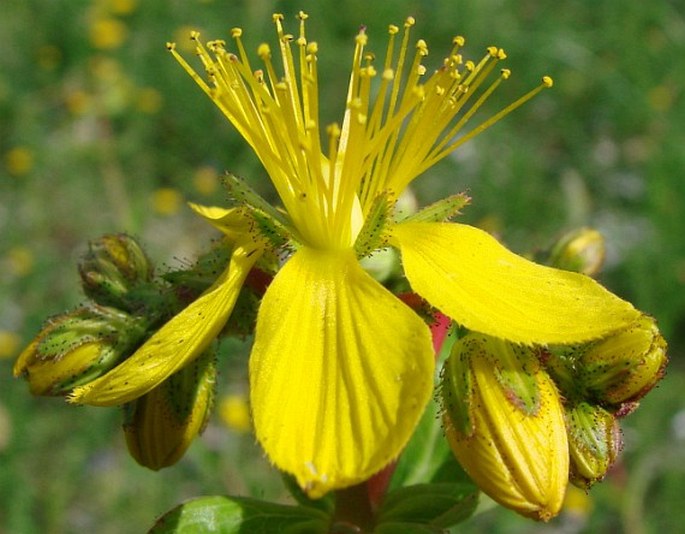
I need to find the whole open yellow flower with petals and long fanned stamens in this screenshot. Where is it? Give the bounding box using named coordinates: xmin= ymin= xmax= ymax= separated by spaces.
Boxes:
xmin=73 ymin=13 xmax=637 ymax=497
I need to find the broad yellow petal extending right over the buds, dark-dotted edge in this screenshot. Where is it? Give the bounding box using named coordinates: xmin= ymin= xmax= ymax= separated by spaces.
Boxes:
xmin=393 ymin=223 xmax=639 ymax=344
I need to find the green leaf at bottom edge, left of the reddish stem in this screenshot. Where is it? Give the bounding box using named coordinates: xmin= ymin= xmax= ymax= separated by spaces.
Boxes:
xmin=149 ymin=495 xmax=330 ymax=534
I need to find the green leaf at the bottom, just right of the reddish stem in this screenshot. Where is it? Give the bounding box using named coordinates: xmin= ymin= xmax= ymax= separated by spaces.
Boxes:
xmin=378 ymin=482 xmax=478 ymax=528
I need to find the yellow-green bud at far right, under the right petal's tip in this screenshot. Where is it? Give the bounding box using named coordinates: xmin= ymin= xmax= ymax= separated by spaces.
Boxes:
xmin=577 ymin=315 xmax=668 ymax=406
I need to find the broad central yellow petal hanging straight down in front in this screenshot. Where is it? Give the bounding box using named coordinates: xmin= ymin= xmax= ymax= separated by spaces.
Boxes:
xmin=250 ymin=248 xmax=434 ymax=497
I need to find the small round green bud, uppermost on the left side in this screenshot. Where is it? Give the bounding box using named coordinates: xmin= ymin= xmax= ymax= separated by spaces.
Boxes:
xmin=78 ymin=234 xmax=153 ymax=311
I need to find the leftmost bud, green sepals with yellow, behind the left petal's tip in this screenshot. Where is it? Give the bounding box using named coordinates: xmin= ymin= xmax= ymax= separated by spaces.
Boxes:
xmin=14 ymin=305 xmax=147 ymax=395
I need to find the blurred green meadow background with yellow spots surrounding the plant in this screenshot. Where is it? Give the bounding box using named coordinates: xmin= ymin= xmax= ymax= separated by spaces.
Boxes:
xmin=0 ymin=0 xmax=685 ymax=534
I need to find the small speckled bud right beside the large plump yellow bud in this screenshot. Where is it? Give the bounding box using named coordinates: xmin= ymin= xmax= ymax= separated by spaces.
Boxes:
xmin=565 ymin=402 xmax=623 ymax=488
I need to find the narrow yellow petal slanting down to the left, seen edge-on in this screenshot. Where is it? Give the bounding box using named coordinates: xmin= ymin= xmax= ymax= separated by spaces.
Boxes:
xmin=69 ymin=244 xmax=261 ymax=406
